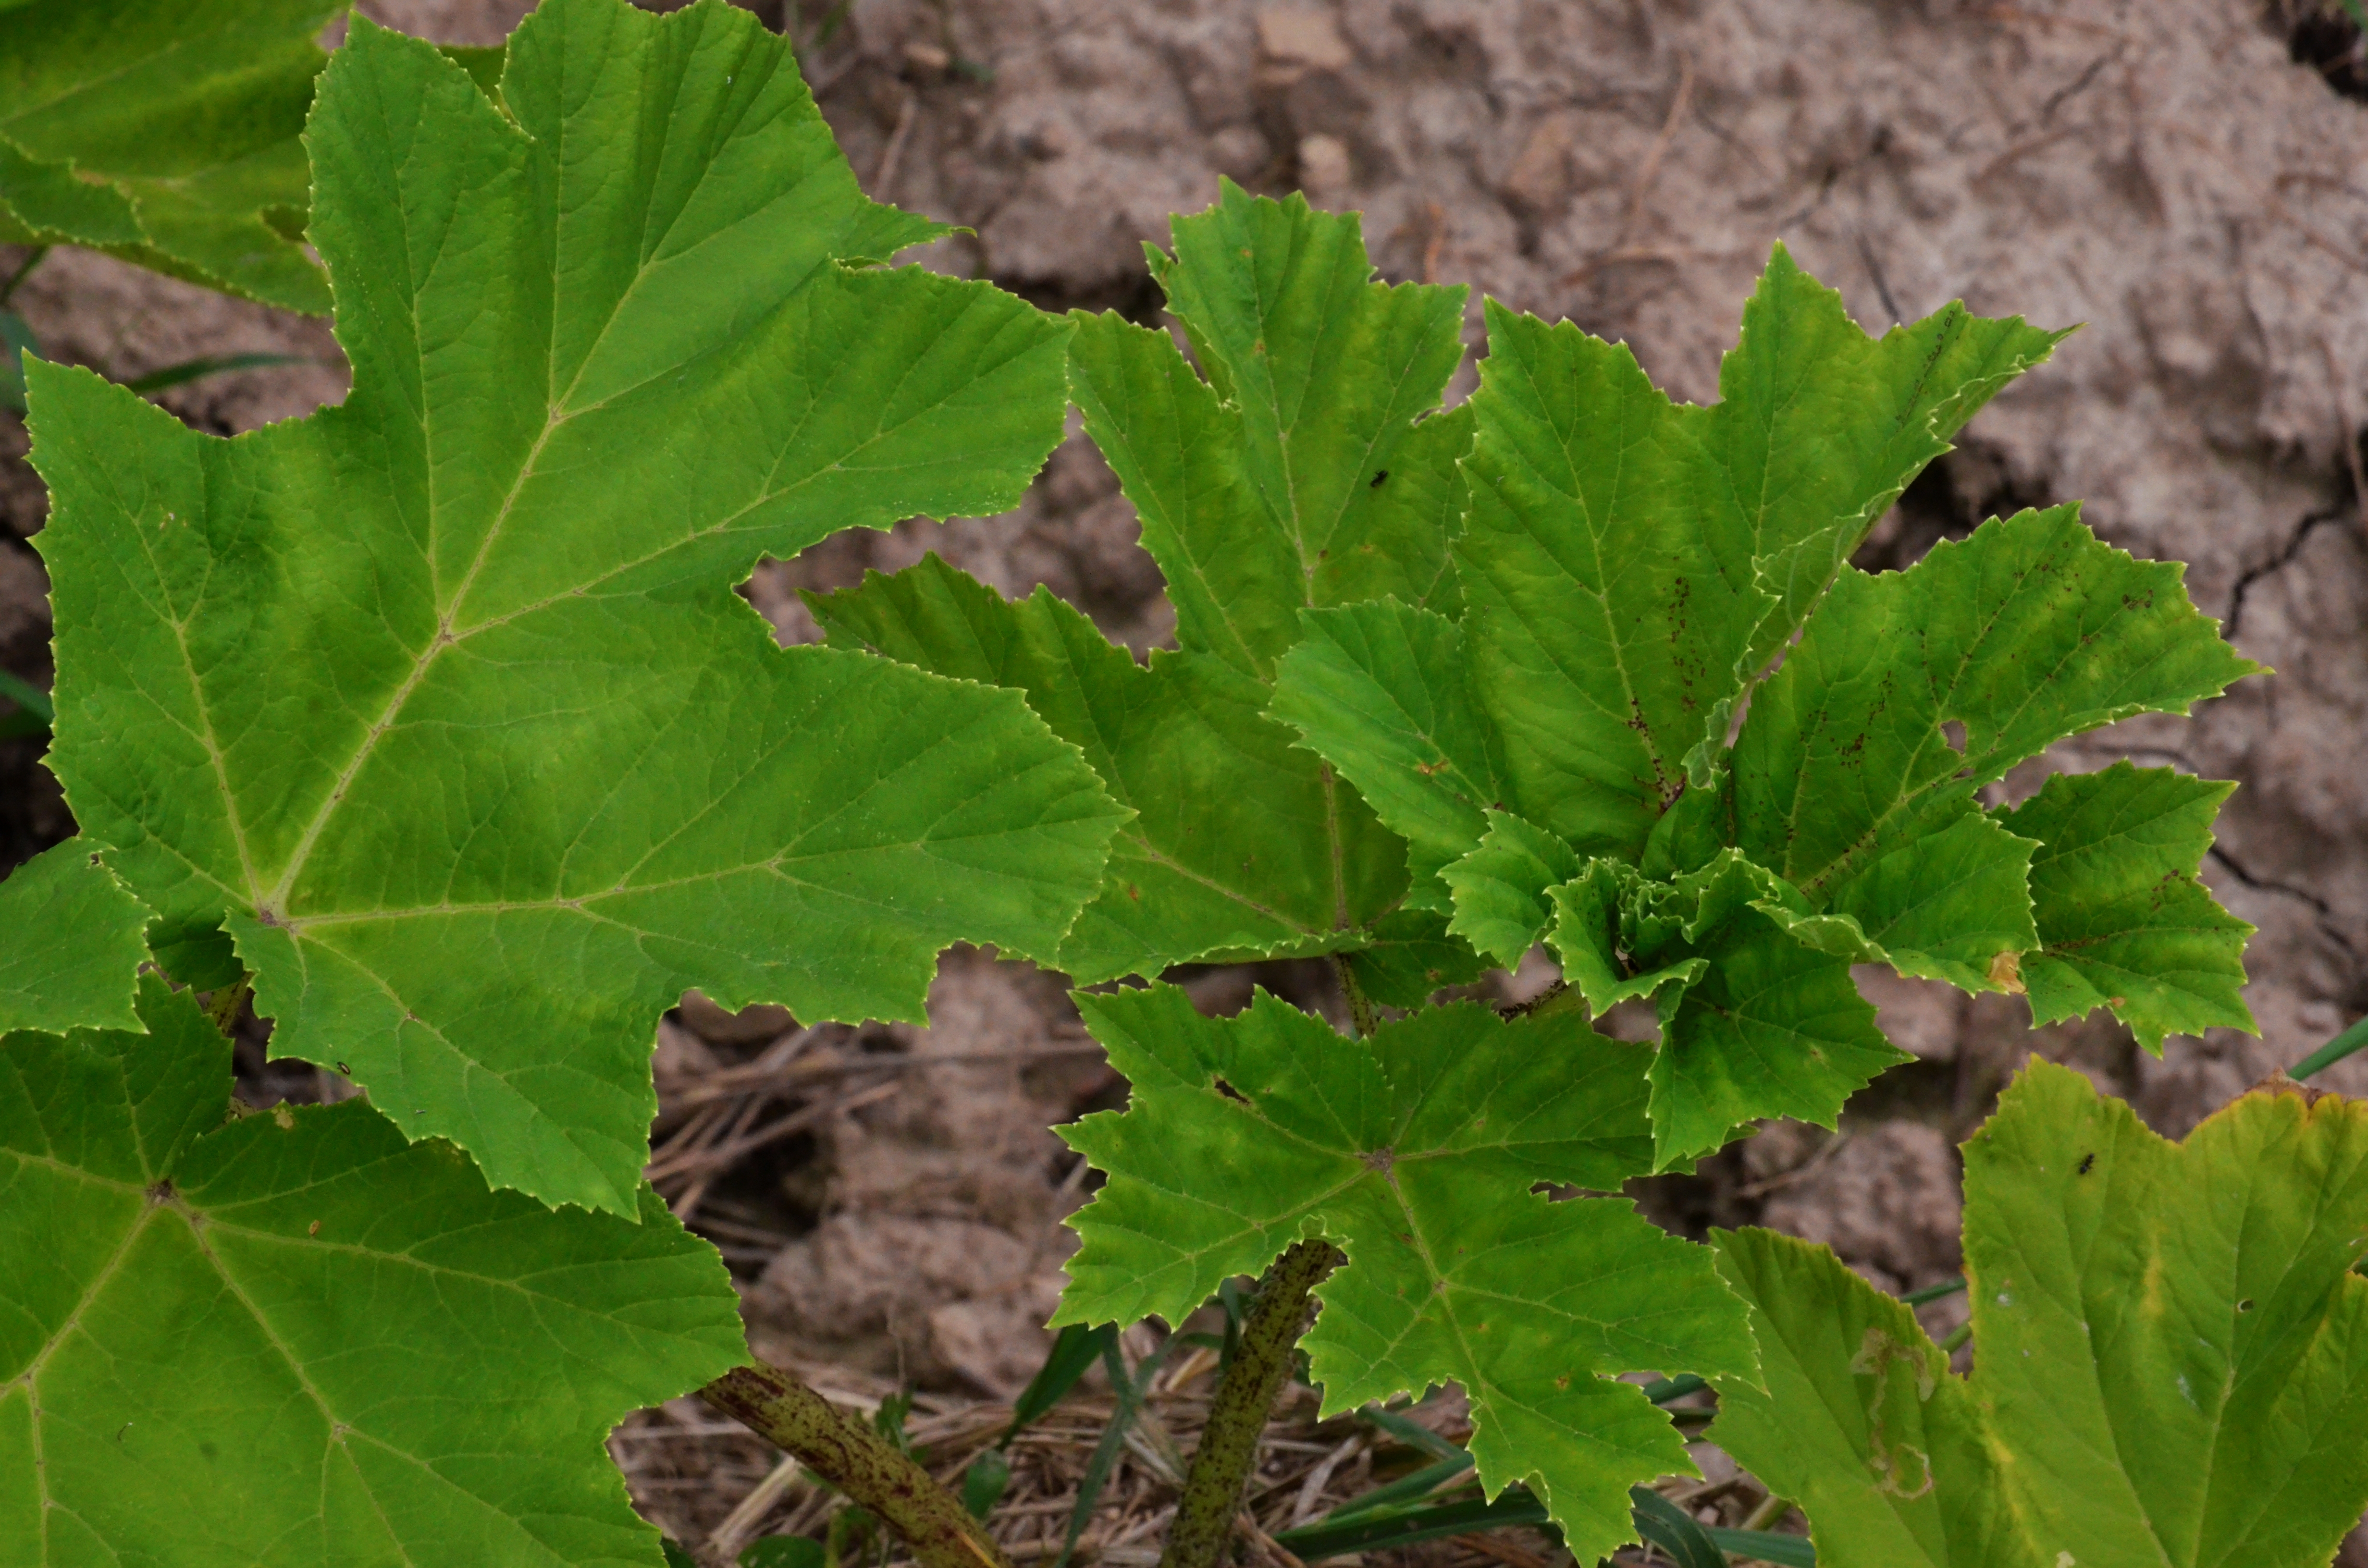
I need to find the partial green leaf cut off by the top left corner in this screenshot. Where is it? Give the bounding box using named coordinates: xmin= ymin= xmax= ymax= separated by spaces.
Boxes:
xmin=0 ymin=0 xmax=345 ymax=315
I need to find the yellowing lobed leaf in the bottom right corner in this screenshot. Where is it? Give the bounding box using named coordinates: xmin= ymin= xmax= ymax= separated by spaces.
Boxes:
xmin=1712 ymin=1061 xmax=2368 ymax=1568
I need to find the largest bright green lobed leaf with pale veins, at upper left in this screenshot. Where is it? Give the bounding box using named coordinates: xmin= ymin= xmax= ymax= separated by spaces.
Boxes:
xmin=31 ymin=0 xmax=1122 ymax=1215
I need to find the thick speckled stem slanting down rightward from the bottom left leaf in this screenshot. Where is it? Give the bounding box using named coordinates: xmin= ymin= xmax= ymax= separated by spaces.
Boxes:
xmin=699 ymin=1362 xmax=1011 ymax=1568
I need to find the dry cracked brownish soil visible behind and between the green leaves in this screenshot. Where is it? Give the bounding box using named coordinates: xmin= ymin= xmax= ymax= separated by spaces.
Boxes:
xmin=0 ymin=0 xmax=2368 ymax=1563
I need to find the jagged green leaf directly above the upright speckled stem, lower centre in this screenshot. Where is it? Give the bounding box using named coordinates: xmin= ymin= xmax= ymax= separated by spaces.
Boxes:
xmin=1056 ymin=985 xmax=1755 ymax=1561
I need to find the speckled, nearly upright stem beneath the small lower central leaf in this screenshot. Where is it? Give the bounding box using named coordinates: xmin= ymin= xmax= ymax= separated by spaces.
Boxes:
xmin=1160 ymin=1241 xmax=1347 ymax=1568
